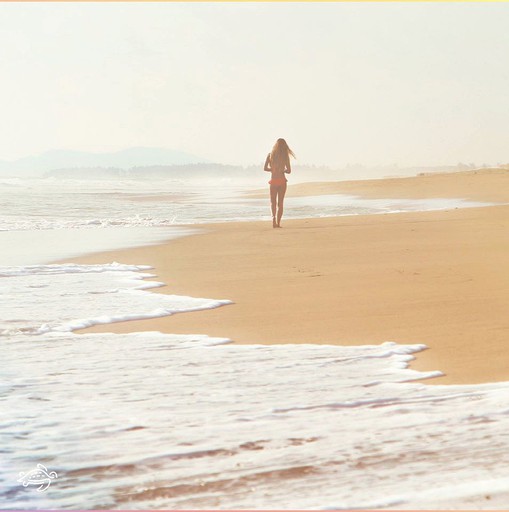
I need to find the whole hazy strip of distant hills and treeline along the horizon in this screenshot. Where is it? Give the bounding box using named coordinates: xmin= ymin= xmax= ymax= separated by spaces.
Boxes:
xmin=0 ymin=147 xmax=496 ymax=181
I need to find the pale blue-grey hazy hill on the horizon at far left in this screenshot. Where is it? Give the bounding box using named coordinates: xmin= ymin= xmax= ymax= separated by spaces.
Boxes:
xmin=0 ymin=147 xmax=207 ymax=177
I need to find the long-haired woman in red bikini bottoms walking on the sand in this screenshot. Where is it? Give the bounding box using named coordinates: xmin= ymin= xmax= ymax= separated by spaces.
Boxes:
xmin=263 ymin=139 xmax=295 ymax=228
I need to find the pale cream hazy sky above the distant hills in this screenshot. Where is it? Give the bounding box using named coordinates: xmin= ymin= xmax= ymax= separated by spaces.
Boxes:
xmin=0 ymin=2 xmax=509 ymax=165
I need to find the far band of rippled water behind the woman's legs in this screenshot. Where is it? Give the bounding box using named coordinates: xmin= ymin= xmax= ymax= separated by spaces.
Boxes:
xmin=0 ymin=178 xmax=492 ymax=231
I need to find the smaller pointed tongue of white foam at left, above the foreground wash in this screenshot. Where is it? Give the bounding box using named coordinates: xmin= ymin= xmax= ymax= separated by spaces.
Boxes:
xmin=0 ymin=263 xmax=230 ymax=336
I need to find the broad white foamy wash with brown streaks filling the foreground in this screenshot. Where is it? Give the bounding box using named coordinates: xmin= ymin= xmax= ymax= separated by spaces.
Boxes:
xmin=0 ymin=333 xmax=509 ymax=509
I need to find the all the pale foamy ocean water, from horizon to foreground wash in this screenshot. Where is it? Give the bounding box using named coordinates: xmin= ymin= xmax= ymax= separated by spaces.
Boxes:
xmin=0 ymin=176 xmax=509 ymax=509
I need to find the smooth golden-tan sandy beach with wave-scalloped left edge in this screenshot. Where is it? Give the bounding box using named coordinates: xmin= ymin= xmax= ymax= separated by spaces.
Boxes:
xmin=72 ymin=170 xmax=509 ymax=384
